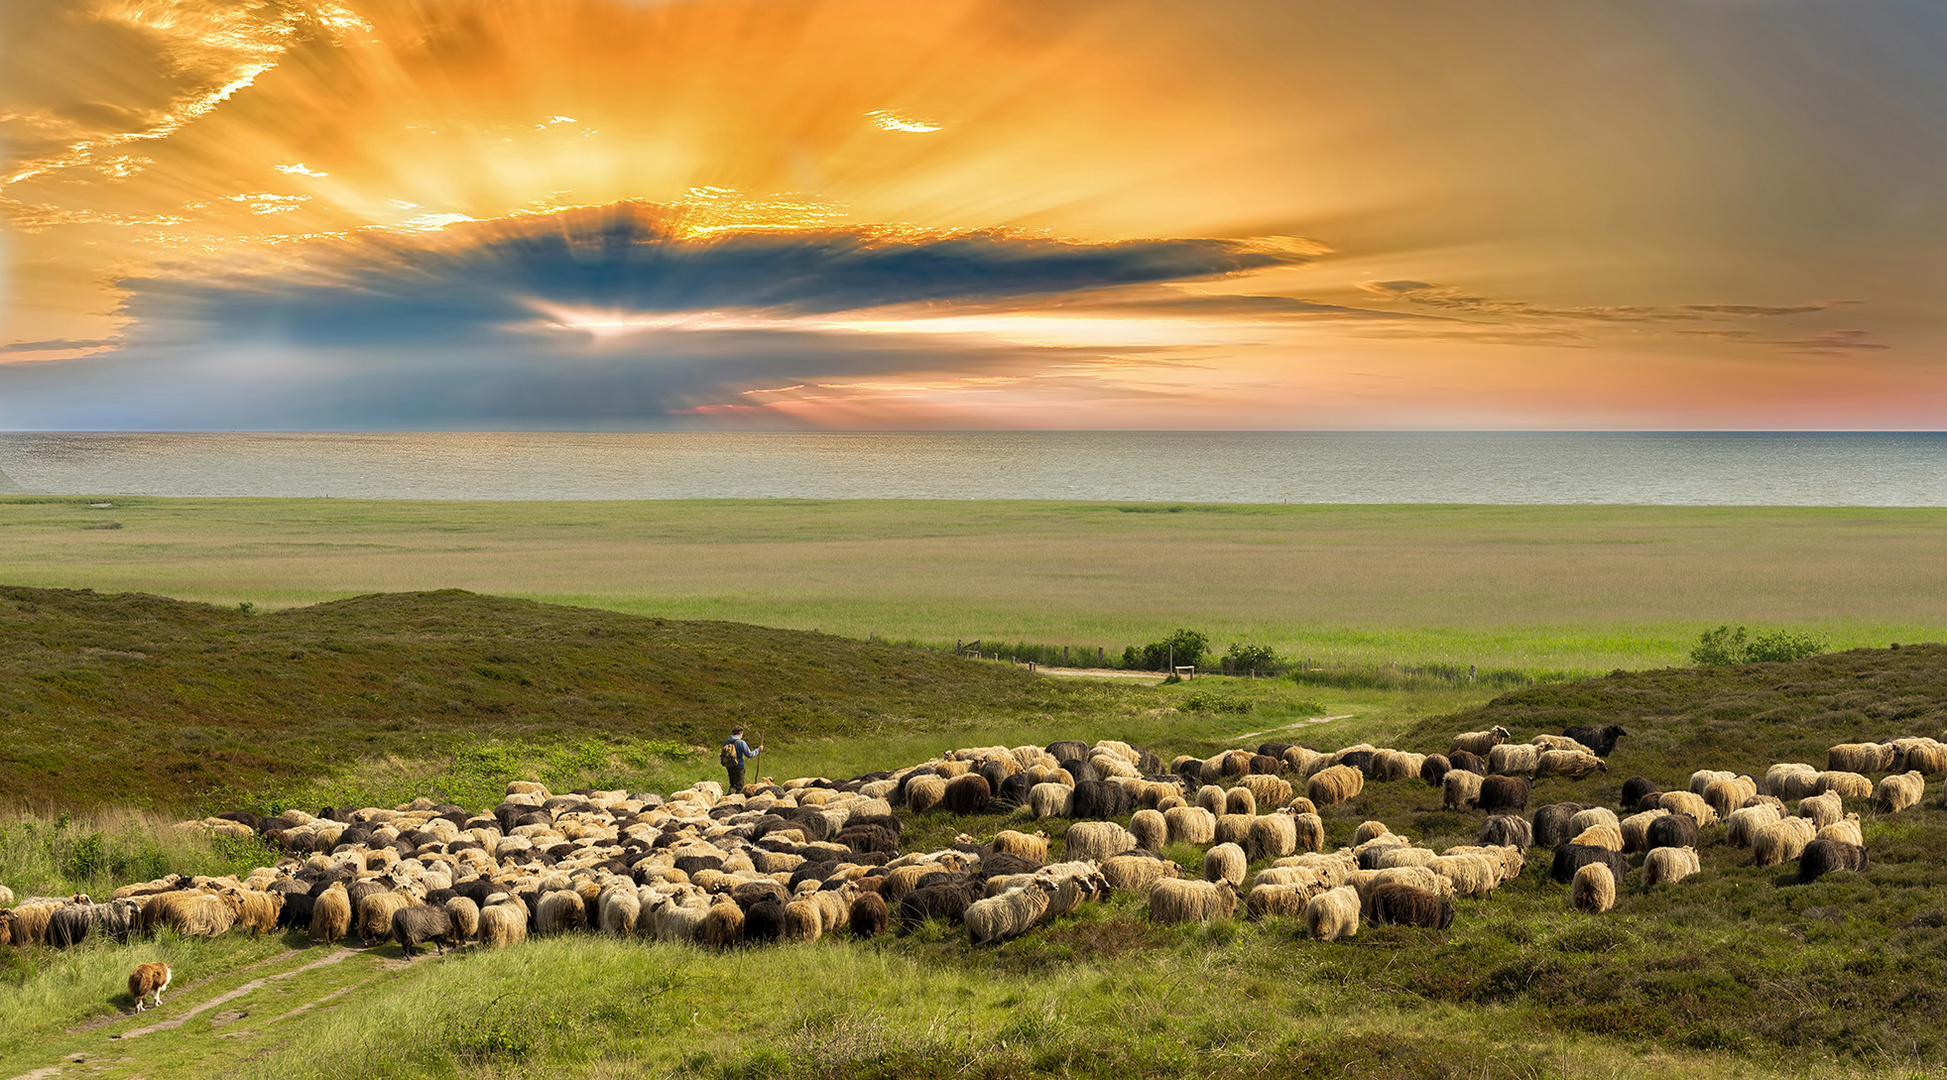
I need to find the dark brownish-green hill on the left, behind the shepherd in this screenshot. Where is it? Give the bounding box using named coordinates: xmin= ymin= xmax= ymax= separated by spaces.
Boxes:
xmin=0 ymin=588 xmax=1133 ymax=808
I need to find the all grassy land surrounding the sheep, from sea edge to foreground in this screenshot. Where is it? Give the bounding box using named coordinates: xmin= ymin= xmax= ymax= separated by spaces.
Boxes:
xmin=0 ymin=498 xmax=1947 ymax=1080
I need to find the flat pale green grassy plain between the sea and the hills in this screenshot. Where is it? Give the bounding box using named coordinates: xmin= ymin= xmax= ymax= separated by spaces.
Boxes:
xmin=0 ymin=496 xmax=1947 ymax=671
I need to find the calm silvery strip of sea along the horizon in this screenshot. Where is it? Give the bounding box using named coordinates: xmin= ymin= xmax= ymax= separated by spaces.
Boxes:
xmin=0 ymin=432 xmax=1947 ymax=506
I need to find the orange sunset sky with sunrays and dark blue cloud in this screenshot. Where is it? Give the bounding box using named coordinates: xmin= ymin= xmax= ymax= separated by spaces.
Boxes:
xmin=0 ymin=0 xmax=1947 ymax=430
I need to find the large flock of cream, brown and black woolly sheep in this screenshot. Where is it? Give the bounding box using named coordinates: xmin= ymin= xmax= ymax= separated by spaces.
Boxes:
xmin=0 ymin=726 xmax=1947 ymax=994
